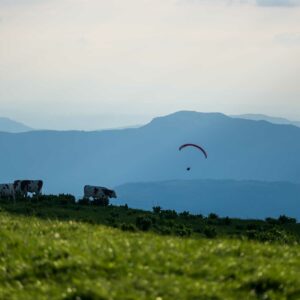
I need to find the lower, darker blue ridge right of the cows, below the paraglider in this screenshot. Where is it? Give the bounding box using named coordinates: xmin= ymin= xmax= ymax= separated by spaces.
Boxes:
xmin=112 ymin=180 xmax=300 ymax=219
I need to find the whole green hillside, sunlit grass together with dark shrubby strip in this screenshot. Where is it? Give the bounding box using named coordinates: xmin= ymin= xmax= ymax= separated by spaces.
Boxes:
xmin=0 ymin=197 xmax=300 ymax=299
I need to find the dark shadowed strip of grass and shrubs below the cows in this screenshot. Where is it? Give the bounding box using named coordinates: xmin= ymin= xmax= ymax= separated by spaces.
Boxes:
xmin=0 ymin=195 xmax=300 ymax=243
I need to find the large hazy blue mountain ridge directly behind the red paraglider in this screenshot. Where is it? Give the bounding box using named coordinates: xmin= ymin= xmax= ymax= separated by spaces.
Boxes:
xmin=0 ymin=111 xmax=300 ymax=195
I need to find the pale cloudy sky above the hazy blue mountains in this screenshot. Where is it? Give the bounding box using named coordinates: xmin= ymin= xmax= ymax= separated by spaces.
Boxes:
xmin=0 ymin=0 xmax=300 ymax=130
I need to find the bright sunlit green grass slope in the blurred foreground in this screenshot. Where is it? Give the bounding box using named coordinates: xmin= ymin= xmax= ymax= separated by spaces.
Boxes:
xmin=0 ymin=211 xmax=300 ymax=300
